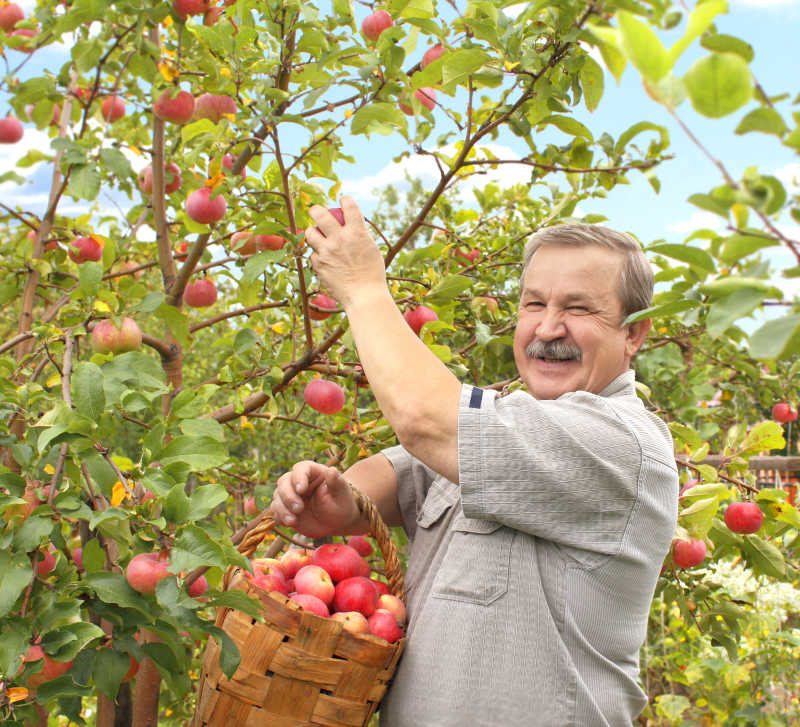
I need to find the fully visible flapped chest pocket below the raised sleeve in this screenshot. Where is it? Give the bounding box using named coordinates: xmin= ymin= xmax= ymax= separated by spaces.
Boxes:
xmin=431 ymin=513 xmax=516 ymax=606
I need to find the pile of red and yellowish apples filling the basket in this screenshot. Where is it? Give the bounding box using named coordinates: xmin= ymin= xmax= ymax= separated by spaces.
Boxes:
xmin=245 ymin=535 xmax=406 ymax=643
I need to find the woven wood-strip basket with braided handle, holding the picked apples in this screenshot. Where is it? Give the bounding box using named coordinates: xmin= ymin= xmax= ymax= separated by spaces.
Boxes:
xmin=192 ymin=488 xmax=405 ymax=727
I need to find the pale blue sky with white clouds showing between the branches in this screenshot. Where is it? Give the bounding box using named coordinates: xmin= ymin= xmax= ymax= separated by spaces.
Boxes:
xmin=0 ymin=0 xmax=800 ymax=294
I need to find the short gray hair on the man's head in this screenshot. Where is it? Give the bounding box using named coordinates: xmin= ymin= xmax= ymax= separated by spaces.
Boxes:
xmin=520 ymin=222 xmax=654 ymax=318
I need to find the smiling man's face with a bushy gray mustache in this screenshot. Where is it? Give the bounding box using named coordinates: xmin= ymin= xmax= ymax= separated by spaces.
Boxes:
xmin=514 ymin=245 xmax=649 ymax=399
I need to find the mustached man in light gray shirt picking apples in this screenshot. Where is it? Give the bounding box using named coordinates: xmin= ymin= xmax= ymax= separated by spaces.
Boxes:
xmin=272 ymin=198 xmax=678 ymax=727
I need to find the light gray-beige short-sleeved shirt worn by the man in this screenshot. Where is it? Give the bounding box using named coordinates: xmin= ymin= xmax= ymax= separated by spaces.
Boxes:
xmin=380 ymin=371 xmax=678 ymax=727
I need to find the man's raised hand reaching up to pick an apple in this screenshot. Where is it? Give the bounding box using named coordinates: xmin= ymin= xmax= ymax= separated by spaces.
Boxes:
xmin=306 ymin=197 xmax=387 ymax=310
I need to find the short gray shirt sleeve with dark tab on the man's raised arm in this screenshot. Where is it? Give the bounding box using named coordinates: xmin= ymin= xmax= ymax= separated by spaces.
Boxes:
xmin=458 ymin=385 xmax=642 ymax=555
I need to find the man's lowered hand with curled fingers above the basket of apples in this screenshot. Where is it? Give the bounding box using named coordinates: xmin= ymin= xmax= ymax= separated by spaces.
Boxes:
xmin=270 ymin=461 xmax=363 ymax=538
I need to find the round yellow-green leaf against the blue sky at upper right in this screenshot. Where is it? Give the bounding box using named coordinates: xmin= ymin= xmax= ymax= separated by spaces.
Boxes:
xmin=683 ymin=53 xmax=753 ymax=119
